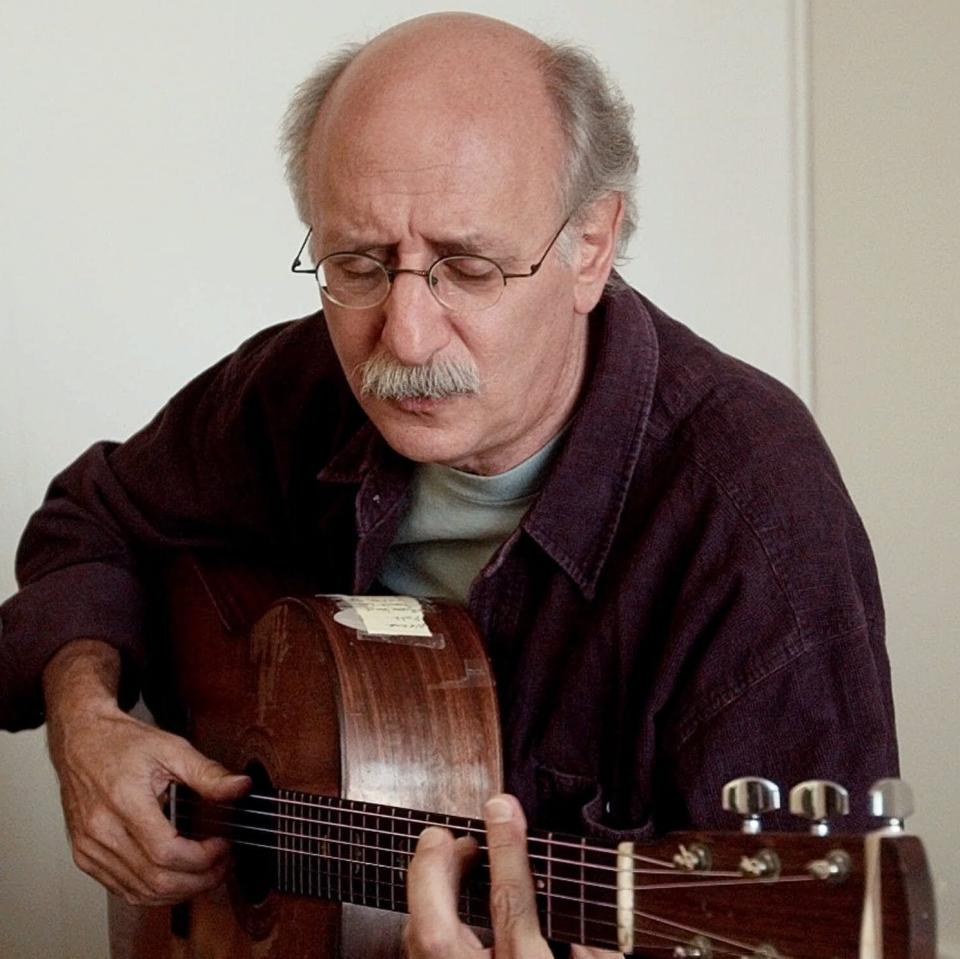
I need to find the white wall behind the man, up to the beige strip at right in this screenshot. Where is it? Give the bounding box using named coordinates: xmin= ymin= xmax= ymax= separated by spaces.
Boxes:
xmin=0 ymin=0 xmax=809 ymax=959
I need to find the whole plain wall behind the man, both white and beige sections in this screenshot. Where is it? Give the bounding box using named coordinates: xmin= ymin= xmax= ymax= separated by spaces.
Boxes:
xmin=0 ymin=0 xmax=960 ymax=959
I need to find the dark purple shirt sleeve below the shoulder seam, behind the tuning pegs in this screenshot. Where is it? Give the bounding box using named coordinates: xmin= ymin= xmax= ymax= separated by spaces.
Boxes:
xmin=671 ymin=628 xmax=899 ymax=831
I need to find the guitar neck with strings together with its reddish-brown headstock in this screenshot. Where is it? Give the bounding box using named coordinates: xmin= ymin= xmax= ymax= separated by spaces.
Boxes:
xmin=170 ymin=788 xmax=935 ymax=959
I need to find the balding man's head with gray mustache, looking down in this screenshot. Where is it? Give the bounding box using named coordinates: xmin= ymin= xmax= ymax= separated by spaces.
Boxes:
xmin=285 ymin=14 xmax=636 ymax=473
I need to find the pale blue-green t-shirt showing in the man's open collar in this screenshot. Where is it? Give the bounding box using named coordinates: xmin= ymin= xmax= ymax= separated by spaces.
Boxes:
xmin=378 ymin=432 xmax=563 ymax=603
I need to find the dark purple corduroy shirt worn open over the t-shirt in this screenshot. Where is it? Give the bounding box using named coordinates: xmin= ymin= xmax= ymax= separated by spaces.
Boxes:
xmin=0 ymin=289 xmax=897 ymax=838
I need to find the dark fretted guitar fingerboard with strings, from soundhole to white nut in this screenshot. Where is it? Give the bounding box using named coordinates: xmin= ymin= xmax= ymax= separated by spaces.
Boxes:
xmin=171 ymin=787 xmax=617 ymax=948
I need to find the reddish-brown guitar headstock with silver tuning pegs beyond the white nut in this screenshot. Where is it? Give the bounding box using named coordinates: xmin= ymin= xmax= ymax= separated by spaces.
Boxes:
xmin=618 ymin=779 xmax=936 ymax=959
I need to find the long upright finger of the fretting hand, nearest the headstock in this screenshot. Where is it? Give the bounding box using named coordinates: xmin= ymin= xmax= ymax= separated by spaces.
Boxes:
xmin=484 ymin=794 xmax=549 ymax=956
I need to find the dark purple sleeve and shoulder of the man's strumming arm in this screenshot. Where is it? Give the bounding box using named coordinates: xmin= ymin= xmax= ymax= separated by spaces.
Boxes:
xmin=0 ymin=318 xmax=344 ymax=730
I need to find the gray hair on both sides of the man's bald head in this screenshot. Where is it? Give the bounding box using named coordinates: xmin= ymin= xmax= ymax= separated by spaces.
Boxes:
xmin=280 ymin=37 xmax=638 ymax=259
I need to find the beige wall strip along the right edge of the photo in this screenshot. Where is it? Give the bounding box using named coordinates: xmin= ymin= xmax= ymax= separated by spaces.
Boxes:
xmin=810 ymin=0 xmax=960 ymax=957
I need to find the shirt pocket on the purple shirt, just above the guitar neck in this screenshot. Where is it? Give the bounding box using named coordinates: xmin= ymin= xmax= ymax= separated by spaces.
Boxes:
xmin=534 ymin=761 xmax=656 ymax=843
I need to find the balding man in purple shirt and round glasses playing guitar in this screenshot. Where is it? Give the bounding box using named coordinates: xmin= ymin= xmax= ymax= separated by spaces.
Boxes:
xmin=0 ymin=14 xmax=896 ymax=956
